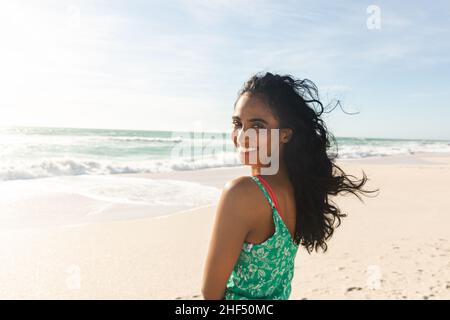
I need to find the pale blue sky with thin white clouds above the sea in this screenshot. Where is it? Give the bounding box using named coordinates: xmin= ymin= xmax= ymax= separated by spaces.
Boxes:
xmin=0 ymin=0 xmax=450 ymax=139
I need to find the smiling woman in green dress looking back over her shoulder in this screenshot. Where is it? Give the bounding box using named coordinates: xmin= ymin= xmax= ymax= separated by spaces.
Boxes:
xmin=202 ymin=73 xmax=373 ymax=300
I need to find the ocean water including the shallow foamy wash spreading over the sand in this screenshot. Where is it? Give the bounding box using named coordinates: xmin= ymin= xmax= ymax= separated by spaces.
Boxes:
xmin=0 ymin=127 xmax=450 ymax=228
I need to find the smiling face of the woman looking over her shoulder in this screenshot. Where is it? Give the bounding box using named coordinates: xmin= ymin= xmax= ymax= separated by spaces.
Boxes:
xmin=231 ymin=93 xmax=280 ymax=166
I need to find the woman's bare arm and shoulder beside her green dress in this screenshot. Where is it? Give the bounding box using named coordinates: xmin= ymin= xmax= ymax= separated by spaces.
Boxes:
xmin=202 ymin=177 xmax=254 ymax=300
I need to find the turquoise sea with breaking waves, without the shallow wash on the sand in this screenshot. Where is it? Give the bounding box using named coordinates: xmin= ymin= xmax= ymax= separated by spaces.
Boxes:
xmin=0 ymin=127 xmax=450 ymax=181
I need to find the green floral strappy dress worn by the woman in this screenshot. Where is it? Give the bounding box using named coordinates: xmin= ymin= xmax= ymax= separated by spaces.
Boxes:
xmin=225 ymin=176 xmax=299 ymax=300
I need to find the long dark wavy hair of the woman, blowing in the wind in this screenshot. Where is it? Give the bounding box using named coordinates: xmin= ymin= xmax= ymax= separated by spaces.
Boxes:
xmin=238 ymin=73 xmax=377 ymax=252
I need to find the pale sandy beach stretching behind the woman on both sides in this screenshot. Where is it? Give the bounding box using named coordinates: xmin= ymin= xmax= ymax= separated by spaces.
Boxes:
xmin=0 ymin=153 xmax=450 ymax=300
